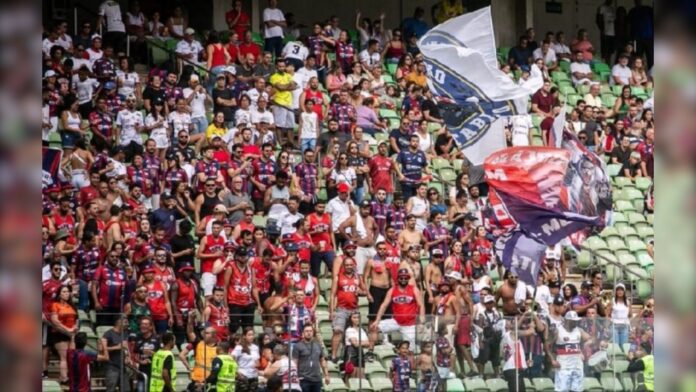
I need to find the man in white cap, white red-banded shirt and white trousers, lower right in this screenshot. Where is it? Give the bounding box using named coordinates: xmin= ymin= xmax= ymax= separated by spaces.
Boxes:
xmin=549 ymin=310 xmax=593 ymax=391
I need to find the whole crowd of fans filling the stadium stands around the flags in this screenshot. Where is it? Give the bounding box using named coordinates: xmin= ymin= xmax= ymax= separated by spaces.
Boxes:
xmin=42 ymin=0 xmax=655 ymax=392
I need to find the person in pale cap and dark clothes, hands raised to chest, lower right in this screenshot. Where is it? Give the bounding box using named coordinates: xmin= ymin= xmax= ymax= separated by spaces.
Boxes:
xmin=475 ymin=295 xmax=503 ymax=377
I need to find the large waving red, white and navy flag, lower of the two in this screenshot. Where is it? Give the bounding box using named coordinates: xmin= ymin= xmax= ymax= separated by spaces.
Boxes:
xmin=484 ymin=144 xmax=612 ymax=286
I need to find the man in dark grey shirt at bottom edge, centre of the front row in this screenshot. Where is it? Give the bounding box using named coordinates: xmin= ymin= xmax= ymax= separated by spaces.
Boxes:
xmin=292 ymin=324 xmax=330 ymax=392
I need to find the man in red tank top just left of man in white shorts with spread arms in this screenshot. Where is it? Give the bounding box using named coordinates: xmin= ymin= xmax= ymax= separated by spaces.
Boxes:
xmin=329 ymin=258 xmax=368 ymax=363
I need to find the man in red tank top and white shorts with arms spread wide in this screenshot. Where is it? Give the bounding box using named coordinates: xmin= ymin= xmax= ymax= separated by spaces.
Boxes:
xmin=370 ymin=268 xmax=425 ymax=351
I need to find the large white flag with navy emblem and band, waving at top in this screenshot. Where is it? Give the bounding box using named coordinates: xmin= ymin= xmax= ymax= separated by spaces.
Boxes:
xmin=418 ymin=7 xmax=543 ymax=165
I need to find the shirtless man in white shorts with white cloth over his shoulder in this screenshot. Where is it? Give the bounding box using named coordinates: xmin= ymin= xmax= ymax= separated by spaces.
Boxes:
xmin=338 ymin=200 xmax=379 ymax=275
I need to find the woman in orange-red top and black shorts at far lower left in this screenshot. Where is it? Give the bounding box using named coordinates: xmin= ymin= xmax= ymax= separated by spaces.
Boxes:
xmin=48 ymin=284 xmax=78 ymax=384
